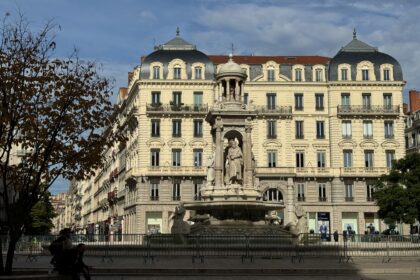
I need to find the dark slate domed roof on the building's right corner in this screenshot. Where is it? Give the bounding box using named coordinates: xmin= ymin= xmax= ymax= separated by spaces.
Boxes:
xmin=328 ymin=32 xmax=403 ymax=81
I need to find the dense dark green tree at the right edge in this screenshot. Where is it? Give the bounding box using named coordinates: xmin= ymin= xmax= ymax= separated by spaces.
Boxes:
xmin=374 ymin=153 xmax=420 ymax=228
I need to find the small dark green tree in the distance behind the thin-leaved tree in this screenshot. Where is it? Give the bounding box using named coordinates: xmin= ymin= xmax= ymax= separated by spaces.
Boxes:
xmin=25 ymin=192 xmax=57 ymax=235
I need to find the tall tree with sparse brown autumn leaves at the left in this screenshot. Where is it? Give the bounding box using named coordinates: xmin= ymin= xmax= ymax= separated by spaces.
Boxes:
xmin=0 ymin=14 xmax=118 ymax=274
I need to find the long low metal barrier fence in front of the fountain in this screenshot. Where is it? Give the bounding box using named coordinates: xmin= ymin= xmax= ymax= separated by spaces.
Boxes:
xmin=0 ymin=234 xmax=420 ymax=262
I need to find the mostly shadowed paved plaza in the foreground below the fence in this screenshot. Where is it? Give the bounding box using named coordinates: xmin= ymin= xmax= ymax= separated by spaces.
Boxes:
xmin=0 ymin=256 xmax=420 ymax=280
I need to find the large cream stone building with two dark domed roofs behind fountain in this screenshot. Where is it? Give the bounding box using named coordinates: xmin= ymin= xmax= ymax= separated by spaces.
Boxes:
xmin=69 ymin=30 xmax=405 ymax=236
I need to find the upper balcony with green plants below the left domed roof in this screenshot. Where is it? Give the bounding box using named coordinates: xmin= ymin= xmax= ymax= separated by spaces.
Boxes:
xmin=146 ymin=103 xmax=208 ymax=115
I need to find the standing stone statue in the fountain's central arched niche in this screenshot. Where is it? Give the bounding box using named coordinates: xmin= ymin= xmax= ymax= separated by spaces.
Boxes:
xmin=225 ymin=139 xmax=243 ymax=184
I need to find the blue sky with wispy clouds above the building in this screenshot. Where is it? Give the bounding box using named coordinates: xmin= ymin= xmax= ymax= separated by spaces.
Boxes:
xmin=0 ymin=0 xmax=420 ymax=193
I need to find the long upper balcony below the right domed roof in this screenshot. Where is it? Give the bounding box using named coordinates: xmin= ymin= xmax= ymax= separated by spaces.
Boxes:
xmin=337 ymin=105 xmax=400 ymax=116
